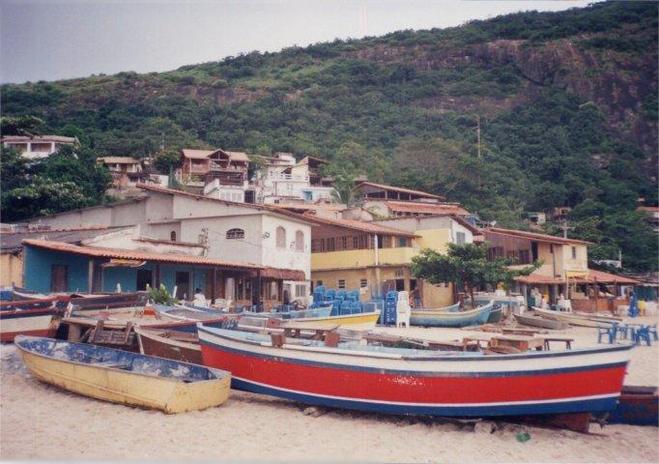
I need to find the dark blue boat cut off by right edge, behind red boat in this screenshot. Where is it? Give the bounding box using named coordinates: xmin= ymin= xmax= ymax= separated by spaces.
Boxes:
xmin=608 ymin=385 xmax=659 ymax=427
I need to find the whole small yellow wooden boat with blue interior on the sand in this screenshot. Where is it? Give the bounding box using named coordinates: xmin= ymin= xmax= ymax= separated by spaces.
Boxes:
xmin=16 ymin=335 xmax=231 ymax=414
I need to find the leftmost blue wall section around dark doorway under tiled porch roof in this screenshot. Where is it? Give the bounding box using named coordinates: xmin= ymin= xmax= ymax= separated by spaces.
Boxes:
xmin=23 ymin=245 xmax=89 ymax=293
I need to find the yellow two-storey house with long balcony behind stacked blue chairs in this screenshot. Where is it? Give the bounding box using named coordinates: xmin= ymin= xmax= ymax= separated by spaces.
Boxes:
xmin=310 ymin=216 xmax=478 ymax=307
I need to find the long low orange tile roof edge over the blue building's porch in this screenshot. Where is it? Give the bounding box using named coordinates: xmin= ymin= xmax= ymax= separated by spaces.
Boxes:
xmin=22 ymin=239 xmax=265 ymax=270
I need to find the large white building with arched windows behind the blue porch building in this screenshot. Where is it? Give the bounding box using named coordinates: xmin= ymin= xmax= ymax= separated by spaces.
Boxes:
xmin=21 ymin=184 xmax=311 ymax=307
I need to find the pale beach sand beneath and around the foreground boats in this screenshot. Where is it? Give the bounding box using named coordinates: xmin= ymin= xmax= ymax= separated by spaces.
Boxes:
xmin=0 ymin=318 xmax=659 ymax=463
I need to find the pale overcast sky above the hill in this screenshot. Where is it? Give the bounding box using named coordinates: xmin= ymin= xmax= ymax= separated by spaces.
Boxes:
xmin=0 ymin=0 xmax=591 ymax=83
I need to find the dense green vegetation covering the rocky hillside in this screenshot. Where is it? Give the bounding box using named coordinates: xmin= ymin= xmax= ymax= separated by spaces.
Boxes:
xmin=1 ymin=2 xmax=658 ymax=270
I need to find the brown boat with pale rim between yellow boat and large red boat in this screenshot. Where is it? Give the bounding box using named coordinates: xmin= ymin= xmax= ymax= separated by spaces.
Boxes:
xmin=134 ymin=327 xmax=202 ymax=364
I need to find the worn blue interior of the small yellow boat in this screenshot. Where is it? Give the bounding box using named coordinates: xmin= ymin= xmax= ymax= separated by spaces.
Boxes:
xmin=15 ymin=336 xmax=221 ymax=383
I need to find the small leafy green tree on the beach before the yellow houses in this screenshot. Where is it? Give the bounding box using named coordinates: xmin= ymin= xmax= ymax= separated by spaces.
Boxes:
xmin=412 ymin=243 xmax=541 ymax=304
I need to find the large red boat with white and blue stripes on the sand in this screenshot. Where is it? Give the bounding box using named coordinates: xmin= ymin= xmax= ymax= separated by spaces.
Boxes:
xmin=197 ymin=324 xmax=631 ymax=417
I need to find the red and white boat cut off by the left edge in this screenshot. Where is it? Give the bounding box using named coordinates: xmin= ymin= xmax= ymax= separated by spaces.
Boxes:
xmin=0 ymin=306 xmax=62 ymax=343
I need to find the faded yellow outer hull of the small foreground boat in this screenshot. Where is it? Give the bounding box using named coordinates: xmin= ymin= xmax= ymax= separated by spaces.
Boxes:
xmin=17 ymin=341 xmax=231 ymax=414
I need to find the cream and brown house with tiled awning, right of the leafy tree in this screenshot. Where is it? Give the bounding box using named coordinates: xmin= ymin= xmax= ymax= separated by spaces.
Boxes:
xmin=484 ymin=227 xmax=638 ymax=311
